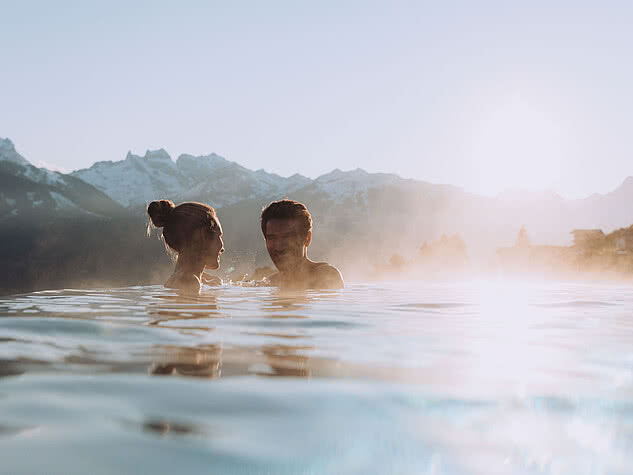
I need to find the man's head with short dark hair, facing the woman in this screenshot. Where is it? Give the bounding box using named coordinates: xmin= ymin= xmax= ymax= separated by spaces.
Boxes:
xmin=261 ymin=200 xmax=312 ymax=270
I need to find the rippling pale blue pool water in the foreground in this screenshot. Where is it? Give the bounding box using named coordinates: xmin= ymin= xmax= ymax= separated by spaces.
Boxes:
xmin=0 ymin=281 xmax=633 ymax=474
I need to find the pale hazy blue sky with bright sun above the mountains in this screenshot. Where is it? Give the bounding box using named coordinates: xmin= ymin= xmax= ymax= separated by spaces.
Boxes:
xmin=0 ymin=0 xmax=633 ymax=197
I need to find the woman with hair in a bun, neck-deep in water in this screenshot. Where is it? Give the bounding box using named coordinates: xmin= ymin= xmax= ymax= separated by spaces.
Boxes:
xmin=147 ymin=200 xmax=224 ymax=294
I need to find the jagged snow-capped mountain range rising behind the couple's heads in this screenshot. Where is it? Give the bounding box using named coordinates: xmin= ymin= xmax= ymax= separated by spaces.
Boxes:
xmin=72 ymin=149 xmax=470 ymax=208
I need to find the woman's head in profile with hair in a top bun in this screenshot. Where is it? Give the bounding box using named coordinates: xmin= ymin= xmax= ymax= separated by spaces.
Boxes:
xmin=147 ymin=200 xmax=224 ymax=269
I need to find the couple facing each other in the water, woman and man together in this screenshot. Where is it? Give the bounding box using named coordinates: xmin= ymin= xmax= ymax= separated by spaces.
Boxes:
xmin=147 ymin=200 xmax=344 ymax=293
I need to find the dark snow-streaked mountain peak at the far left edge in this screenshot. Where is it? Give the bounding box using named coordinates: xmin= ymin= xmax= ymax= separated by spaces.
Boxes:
xmin=0 ymin=139 xmax=121 ymax=219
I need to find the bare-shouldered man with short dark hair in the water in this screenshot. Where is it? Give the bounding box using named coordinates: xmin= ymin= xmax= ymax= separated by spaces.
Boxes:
xmin=261 ymin=200 xmax=344 ymax=289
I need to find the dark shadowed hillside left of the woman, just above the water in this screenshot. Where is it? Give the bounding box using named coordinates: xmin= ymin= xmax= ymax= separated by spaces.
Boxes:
xmin=0 ymin=216 xmax=173 ymax=294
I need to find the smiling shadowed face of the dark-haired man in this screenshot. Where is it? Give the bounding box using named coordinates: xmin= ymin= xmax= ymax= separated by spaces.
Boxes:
xmin=266 ymin=219 xmax=309 ymax=270
